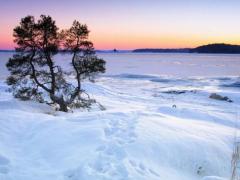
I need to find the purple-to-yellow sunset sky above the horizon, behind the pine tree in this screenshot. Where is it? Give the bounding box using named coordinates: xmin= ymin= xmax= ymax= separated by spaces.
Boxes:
xmin=0 ymin=0 xmax=240 ymax=49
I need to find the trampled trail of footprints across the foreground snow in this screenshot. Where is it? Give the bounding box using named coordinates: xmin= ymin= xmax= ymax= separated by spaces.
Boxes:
xmin=66 ymin=115 xmax=139 ymax=180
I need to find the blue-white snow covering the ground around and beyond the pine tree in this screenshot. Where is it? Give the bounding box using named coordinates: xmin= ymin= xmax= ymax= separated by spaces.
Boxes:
xmin=0 ymin=54 xmax=240 ymax=180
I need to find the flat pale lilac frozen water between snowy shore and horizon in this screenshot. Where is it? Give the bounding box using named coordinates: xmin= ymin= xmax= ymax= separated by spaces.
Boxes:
xmin=0 ymin=53 xmax=240 ymax=77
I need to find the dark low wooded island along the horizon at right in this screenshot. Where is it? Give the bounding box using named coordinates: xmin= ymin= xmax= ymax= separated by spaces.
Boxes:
xmin=132 ymin=43 xmax=240 ymax=54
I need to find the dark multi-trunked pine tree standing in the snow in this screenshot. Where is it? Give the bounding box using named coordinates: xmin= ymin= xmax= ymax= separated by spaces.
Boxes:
xmin=6 ymin=15 xmax=105 ymax=112
